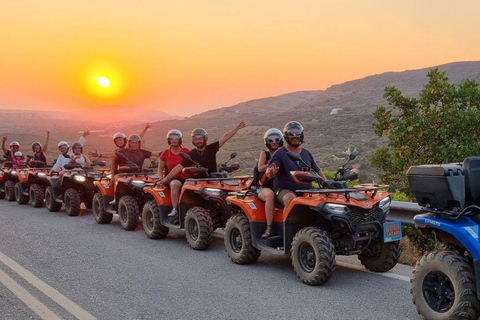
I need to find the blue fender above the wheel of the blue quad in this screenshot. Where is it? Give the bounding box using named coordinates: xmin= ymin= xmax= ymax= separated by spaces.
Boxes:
xmin=413 ymin=213 xmax=480 ymax=260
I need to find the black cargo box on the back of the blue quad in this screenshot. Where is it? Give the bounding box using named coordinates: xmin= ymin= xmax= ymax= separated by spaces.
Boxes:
xmin=407 ymin=163 xmax=465 ymax=211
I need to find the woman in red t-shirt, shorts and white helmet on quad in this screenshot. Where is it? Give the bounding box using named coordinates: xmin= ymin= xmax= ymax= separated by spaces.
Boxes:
xmin=158 ymin=129 xmax=190 ymax=217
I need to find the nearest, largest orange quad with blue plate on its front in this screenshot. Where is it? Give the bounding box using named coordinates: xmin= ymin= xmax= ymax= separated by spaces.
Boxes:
xmin=224 ymin=151 xmax=401 ymax=285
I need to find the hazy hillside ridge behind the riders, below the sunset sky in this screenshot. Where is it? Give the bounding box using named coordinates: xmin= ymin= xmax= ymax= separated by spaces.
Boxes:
xmin=0 ymin=61 xmax=480 ymax=181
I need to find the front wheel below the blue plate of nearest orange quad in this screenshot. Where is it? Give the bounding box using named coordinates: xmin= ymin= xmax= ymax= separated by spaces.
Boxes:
xmin=358 ymin=237 xmax=400 ymax=272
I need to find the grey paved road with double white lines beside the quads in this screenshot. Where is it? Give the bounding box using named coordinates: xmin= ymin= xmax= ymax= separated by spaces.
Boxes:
xmin=0 ymin=200 xmax=419 ymax=320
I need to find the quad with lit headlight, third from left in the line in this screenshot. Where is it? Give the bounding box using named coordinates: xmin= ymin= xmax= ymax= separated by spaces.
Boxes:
xmin=45 ymin=160 xmax=107 ymax=216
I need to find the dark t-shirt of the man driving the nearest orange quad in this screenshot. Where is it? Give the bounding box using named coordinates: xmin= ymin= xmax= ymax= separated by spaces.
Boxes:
xmin=268 ymin=147 xmax=320 ymax=191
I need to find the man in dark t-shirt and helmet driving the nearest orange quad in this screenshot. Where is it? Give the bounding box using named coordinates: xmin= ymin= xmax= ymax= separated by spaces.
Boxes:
xmin=266 ymin=121 xmax=326 ymax=212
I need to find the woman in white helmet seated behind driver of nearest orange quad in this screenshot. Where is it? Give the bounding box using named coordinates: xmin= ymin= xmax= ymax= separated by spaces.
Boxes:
xmin=257 ymin=128 xmax=283 ymax=238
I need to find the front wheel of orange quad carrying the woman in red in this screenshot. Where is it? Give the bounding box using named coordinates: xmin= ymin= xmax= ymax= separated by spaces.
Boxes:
xmin=185 ymin=207 xmax=213 ymax=250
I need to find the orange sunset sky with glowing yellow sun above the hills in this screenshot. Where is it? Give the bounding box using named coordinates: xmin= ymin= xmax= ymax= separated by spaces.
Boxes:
xmin=0 ymin=0 xmax=480 ymax=115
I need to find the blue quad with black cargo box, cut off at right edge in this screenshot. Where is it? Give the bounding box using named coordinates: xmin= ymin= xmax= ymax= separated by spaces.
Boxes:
xmin=407 ymin=157 xmax=480 ymax=320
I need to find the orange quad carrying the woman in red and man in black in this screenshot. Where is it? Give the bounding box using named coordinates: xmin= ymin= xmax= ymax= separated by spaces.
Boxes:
xmin=142 ymin=152 xmax=252 ymax=250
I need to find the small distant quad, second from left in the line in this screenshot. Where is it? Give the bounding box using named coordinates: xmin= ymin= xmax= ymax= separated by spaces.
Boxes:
xmin=15 ymin=156 xmax=51 ymax=208
